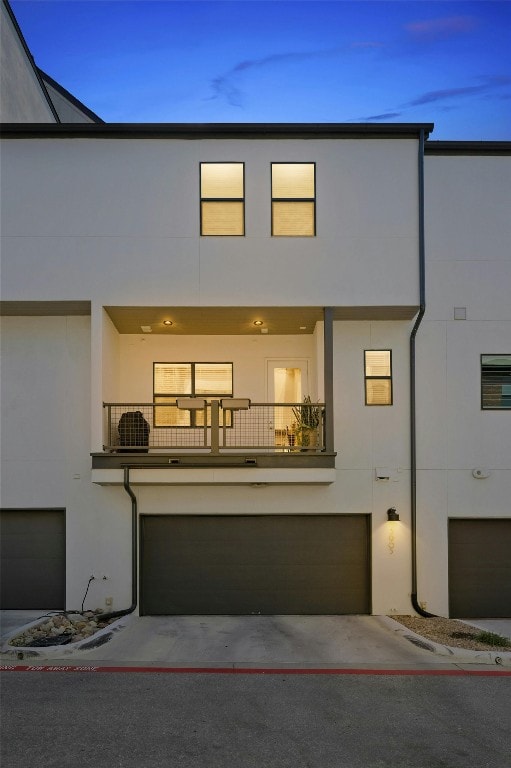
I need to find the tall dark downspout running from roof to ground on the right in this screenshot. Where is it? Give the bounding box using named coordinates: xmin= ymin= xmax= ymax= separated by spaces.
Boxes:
xmin=410 ymin=128 xmax=435 ymax=618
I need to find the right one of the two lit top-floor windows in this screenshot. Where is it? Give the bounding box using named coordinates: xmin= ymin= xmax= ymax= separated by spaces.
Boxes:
xmin=271 ymin=163 xmax=316 ymax=237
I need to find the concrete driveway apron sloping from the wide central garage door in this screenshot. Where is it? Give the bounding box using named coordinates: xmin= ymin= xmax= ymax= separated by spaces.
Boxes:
xmin=74 ymin=616 xmax=438 ymax=667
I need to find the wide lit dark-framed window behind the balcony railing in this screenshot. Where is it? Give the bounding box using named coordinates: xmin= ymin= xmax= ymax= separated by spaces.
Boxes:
xmin=153 ymin=363 xmax=233 ymax=427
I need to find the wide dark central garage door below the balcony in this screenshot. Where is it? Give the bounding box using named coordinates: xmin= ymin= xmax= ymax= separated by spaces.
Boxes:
xmin=141 ymin=515 xmax=370 ymax=615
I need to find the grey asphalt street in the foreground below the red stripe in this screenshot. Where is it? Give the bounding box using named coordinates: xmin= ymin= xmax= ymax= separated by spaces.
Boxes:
xmin=1 ymin=670 xmax=511 ymax=768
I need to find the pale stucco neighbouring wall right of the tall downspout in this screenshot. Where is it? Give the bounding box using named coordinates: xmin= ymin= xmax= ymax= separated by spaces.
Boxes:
xmin=417 ymin=149 xmax=511 ymax=614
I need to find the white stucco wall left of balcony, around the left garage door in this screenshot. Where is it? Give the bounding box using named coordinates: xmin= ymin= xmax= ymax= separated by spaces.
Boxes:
xmin=0 ymin=317 xmax=144 ymax=609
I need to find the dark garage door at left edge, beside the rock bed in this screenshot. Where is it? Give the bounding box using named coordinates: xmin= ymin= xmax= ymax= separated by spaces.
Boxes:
xmin=0 ymin=509 xmax=66 ymax=610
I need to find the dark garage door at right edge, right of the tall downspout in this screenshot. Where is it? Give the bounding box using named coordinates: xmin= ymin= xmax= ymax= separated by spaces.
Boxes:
xmin=449 ymin=519 xmax=511 ymax=618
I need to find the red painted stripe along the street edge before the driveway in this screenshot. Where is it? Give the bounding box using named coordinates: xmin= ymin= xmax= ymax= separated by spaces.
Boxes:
xmin=0 ymin=664 xmax=511 ymax=677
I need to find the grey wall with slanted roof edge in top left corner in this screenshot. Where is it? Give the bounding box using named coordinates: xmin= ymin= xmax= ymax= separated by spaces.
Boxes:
xmin=0 ymin=2 xmax=58 ymax=123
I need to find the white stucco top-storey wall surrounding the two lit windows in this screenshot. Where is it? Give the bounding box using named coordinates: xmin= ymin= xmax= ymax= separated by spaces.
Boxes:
xmin=1 ymin=139 xmax=418 ymax=306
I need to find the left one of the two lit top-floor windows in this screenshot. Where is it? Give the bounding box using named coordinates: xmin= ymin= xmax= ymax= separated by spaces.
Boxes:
xmin=200 ymin=163 xmax=245 ymax=235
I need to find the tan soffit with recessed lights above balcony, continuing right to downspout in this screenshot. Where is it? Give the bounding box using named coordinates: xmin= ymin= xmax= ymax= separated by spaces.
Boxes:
xmin=105 ymin=306 xmax=418 ymax=336
